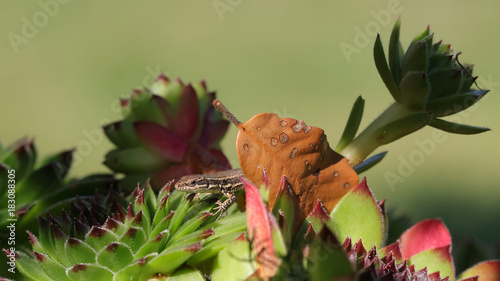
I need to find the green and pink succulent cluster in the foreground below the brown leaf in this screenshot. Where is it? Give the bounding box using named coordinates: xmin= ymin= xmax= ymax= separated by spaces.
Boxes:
xmin=212 ymin=174 xmax=500 ymax=281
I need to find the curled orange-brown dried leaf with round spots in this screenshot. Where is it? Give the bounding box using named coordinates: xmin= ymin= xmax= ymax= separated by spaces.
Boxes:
xmin=214 ymin=100 xmax=359 ymax=229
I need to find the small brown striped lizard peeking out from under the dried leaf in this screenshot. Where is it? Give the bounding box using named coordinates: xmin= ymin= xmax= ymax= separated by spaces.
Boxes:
xmin=174 ymin=169 xmax=243 ymax=220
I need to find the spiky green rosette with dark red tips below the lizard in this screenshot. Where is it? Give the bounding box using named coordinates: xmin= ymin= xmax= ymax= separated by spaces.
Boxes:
xmin=10 ymin=179 xmax=246 ymax=280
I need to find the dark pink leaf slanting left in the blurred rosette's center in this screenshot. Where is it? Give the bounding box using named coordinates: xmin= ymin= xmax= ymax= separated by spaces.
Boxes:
xmin=134 ymin=121 xmax=188 ymax=162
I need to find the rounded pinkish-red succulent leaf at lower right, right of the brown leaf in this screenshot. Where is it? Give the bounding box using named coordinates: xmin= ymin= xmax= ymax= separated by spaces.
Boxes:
xmin=399 ymin=219 xmax=451 ymax=258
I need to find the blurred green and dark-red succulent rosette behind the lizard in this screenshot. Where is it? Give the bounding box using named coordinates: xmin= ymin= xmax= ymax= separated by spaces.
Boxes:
xmin=104 ymin=75 xmax=231 ymax=190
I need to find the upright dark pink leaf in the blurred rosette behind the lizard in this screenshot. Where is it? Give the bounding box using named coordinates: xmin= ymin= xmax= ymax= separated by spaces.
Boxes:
xmin=175 ymin=84 xmax=199 ymax=139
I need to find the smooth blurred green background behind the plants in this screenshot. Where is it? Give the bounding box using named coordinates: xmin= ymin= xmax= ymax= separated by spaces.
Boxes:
xmin=0 ymin=0 xmax=500 ymax=254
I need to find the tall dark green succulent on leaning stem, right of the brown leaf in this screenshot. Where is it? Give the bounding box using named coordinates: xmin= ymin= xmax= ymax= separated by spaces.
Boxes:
xmin=335 ymin=18 xmax=489 ymax=166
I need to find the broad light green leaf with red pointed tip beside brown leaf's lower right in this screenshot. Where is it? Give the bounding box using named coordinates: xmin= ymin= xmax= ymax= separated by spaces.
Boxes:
xmin=331 ymin=179 xmax=386 ymax=248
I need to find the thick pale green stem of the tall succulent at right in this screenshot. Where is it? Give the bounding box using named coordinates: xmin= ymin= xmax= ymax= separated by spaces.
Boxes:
xmin=339 ymin=102 xmax=415 ymax=166
